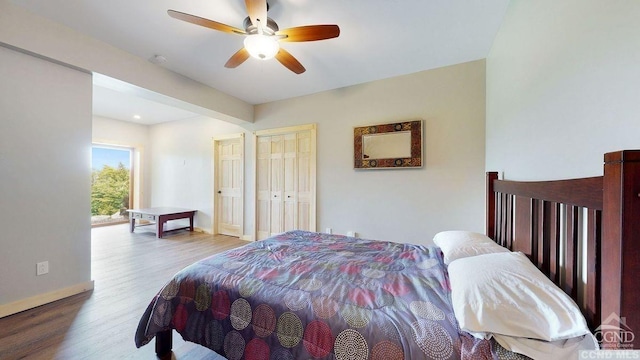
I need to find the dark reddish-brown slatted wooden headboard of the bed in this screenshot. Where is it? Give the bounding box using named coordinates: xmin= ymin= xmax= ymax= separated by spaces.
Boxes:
xmin=486 ymin=150 xmax=640 ymax=349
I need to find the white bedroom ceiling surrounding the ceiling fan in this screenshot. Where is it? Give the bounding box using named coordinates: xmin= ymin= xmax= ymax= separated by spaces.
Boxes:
xmin=13 ymin=0 xmax=509 ymax=121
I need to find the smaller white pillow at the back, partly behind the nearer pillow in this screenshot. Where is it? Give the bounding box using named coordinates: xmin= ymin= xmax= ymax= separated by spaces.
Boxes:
xmin=433 ymin=230 xmax=509 ymax=264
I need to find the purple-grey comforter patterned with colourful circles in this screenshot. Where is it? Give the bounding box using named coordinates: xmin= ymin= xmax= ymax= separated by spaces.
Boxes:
xmin=135 ymin=231 xmax=504 ymax=360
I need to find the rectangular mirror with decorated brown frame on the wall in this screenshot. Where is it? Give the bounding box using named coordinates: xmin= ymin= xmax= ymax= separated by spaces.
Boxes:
xmin=353 ymin=120 xmax=422 ymax=169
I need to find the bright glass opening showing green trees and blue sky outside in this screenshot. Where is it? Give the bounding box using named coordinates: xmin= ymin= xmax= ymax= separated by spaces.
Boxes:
xmin=91 ymin=144 xmax=133 ymax=226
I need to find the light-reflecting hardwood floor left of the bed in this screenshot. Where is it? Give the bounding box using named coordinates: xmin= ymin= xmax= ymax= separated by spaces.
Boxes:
xmin=0 ymin=224 xmax=246 ymax=360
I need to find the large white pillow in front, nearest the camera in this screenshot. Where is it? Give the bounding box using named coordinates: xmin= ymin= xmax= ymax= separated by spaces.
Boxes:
xmin=448 ymin=252 xmax=589 ymax=341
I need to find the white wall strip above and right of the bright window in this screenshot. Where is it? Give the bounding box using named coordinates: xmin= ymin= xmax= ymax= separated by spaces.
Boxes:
xmin=92 ymin=115 xmax=151 ymax=209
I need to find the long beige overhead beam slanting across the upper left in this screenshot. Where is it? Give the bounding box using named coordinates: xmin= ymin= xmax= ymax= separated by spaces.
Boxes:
xmin=0 ymin=0 xmax=253 ymax=123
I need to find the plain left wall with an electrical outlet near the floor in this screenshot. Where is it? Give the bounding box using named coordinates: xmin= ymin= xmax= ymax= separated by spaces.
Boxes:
xmin=0 ymin=47 xmax=92 ymax=310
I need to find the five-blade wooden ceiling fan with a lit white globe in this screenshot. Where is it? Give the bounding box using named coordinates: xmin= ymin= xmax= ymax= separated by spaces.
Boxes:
xmin=167 ymin=0 xmax=340 ymax=74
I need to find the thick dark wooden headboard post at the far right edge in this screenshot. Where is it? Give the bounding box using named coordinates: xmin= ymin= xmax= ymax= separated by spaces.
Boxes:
xmin=596 ymin=150 xmax=640 ymax=349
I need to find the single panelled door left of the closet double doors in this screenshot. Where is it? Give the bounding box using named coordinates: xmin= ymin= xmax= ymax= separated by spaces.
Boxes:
xmin=216 ymin=137 xmax=244 ymax=237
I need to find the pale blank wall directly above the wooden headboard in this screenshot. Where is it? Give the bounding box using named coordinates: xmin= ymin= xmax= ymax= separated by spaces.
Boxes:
xmin=486 ymin=0 xmax=640 ymax=180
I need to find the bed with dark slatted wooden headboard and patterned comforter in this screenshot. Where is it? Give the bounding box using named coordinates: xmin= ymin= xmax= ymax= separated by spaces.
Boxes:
xmin=135 ymin=151 xmax=640 ymax=360
